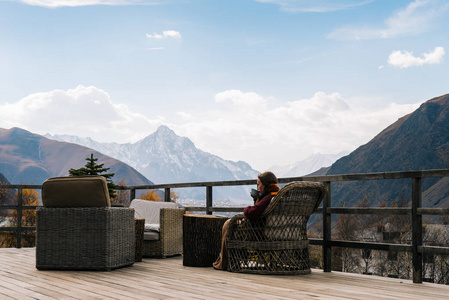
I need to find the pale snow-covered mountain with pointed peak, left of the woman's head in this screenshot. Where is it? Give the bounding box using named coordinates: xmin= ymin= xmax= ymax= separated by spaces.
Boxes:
xmin=46 ymin=126 xmax=259 ymax=201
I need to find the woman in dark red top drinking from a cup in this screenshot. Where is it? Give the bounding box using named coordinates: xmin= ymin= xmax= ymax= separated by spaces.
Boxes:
xmin=213 ymin=172 xmax=279 ymax=271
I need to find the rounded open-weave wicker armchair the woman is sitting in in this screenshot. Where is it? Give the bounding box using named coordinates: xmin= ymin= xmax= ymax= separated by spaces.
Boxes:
xmin=227 ymin=181 xmax=325 ymax=274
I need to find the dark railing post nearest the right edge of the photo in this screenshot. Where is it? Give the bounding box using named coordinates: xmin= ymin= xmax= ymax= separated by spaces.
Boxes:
xmin=412 ymin=177 xmax=423 ymax=283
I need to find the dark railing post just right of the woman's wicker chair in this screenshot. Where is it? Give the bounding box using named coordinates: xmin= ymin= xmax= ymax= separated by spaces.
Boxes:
xmin=323 ymin=181 xmax=332 ymax=272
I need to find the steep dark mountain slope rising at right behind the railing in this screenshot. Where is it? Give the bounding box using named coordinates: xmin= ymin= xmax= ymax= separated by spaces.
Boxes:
xmin=327 ymin=94 xmax=449 ymax=207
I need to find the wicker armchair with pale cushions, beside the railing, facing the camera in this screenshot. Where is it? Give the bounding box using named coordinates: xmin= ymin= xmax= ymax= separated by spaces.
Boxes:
xmin=129 ymin=199 xmax=185 ymax=258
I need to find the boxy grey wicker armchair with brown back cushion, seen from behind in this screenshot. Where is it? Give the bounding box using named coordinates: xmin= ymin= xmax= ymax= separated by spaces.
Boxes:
xmin=36 ymin=176 xmax=135 ymax=271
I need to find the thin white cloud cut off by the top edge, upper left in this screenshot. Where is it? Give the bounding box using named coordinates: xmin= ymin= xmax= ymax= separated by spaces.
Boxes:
xmin=13 ymin=0 xmax=166 ymax=8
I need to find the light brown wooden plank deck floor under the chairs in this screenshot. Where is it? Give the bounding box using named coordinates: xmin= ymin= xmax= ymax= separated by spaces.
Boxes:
xmin=0 ymin=248 xmax=449 ymax=300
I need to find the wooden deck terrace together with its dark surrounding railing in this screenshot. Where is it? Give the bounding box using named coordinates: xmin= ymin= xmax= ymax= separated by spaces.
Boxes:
xmin=0 ymin=170 xmax=449 ymax=299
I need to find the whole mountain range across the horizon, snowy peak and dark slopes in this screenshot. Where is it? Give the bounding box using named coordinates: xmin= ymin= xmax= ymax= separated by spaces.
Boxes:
xmin=0 ymin=94 xmax=449 ymax=207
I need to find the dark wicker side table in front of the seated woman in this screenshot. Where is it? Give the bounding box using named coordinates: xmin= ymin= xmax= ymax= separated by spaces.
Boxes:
xmin=182 ymin=214 xmax=229 ymax=267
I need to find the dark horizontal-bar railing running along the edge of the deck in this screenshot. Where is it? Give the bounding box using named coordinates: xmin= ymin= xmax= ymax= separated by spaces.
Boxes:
xmin=0 ymin=169 xmax=449 ymax=283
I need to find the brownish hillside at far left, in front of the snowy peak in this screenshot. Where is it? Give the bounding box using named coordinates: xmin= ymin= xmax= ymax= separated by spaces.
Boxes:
xmin=0 ymin=128 xmax=151 ymax=185
